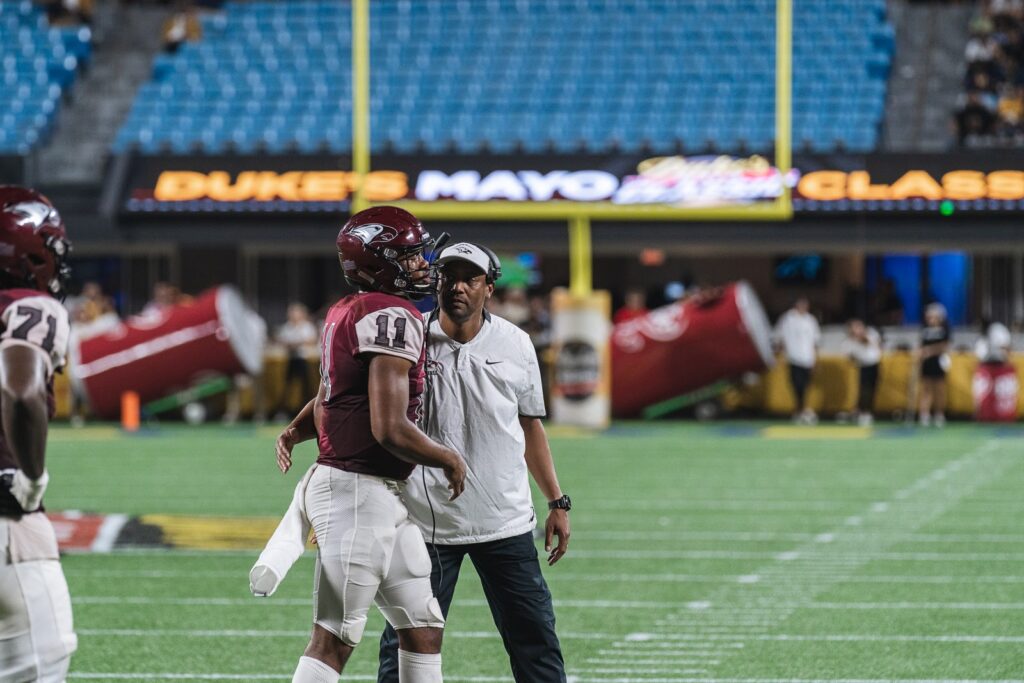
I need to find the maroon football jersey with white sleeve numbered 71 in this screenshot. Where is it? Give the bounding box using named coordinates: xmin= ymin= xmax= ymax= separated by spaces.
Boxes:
xmin=0 ymin=289 xmax=70 ymax=516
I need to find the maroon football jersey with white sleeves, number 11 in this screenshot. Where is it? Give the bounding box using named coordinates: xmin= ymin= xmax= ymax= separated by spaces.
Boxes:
xmin=316 ymin=292 xmax=426 ymax=479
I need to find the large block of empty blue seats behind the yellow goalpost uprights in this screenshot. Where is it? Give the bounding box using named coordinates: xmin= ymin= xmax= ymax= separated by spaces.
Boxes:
xmin=115 ymin=0 xmax=894 ymax=153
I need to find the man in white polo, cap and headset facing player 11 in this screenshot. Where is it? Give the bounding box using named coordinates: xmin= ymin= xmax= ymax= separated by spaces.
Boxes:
xmin=377 ymin=243 xmax=570 ymax=683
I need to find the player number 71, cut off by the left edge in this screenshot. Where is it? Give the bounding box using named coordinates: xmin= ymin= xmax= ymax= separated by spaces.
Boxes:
xmin=0 ymin=185 xmax=77 ymax=683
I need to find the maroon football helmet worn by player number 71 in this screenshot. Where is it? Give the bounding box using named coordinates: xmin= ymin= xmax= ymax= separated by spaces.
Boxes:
xmin=0 ymin=185 xmax=71 ymax=299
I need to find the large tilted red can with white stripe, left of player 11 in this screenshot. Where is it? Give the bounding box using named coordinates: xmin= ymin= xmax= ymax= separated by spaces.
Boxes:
xmin=72 ymin=287 xmax=266 ymax=419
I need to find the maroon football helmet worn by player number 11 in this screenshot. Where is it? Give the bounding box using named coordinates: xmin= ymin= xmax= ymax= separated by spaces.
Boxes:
xmin=338 ymin=206 xmax=436 ymax=300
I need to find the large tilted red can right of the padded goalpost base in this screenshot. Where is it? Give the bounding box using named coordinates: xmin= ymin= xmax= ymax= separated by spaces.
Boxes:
xmin=611 ymin=282 xmax=774 ymax=417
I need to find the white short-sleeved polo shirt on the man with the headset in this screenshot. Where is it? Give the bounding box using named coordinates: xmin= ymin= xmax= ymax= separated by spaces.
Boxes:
xmin=404 ymin=314 xmax=545 ymax=545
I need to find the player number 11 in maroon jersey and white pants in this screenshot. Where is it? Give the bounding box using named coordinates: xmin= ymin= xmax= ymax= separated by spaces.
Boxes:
xmin=268 ymin=207 xmax=466 ymax=683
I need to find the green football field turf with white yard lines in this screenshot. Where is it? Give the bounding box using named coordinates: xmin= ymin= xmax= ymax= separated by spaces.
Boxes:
xmin=47 ymin=423 xmax=1024 ymax=683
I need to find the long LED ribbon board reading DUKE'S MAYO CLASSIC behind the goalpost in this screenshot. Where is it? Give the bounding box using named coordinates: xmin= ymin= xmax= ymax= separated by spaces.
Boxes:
xmin=116 ymin=151 xmax=1024 ymax=217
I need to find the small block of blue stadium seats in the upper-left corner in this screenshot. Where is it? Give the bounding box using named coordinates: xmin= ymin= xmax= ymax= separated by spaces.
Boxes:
xmin=0 ymin=0 xmax=92 ymax=155
